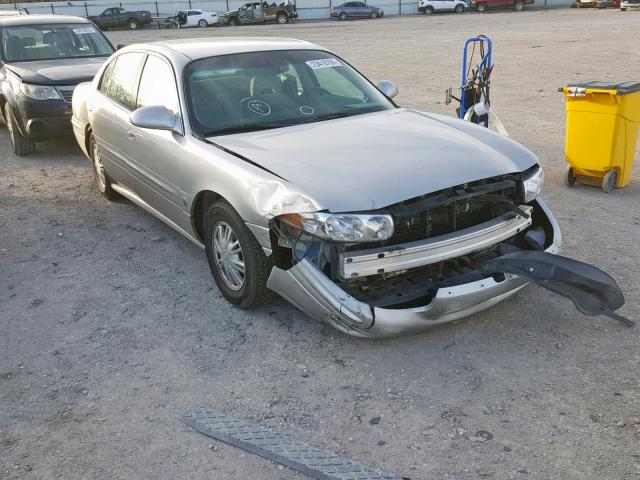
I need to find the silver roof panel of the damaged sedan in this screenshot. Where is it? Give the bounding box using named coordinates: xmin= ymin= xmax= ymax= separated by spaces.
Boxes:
xmin=132 ymin=37 xmax=326 ymax=60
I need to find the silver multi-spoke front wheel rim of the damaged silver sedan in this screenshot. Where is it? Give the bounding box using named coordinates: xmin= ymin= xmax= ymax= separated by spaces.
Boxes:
xmin=212 ymin=222 xmax=245 ymax=291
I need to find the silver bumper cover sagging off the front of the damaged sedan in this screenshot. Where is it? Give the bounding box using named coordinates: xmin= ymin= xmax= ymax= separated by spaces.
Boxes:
xmin=267 ymin=198 xmax=562 ymax=337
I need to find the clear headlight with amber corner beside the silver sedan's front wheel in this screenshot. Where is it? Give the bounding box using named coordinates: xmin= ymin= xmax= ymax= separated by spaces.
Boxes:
xmin=278 ymin=212 xmax=393 ymax=242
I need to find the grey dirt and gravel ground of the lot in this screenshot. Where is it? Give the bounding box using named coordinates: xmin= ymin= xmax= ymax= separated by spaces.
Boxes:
xmin=0 ymin=10 xmax=640 ymax=480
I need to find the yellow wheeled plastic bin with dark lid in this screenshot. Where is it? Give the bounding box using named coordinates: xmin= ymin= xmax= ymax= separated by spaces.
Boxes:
xmin=562 ymin=82 xmax=640 ymax=192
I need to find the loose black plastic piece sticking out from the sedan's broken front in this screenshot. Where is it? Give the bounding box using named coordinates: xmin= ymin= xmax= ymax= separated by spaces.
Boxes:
xmin=480 ymin=251 xmax=635 ymax=326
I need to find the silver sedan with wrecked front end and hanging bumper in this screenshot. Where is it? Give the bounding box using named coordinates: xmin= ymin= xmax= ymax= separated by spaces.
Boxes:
xmin=73 ymin=38 xmax=626 ymax=337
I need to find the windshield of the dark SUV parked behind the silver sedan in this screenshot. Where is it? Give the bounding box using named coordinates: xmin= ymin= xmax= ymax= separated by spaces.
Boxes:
xmin=2 ymin=23 xmax=113 ymax=62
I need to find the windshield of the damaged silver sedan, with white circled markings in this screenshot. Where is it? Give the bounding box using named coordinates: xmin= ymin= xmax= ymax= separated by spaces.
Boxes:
xmin=185 ymin=50 xmax=394 ymax=136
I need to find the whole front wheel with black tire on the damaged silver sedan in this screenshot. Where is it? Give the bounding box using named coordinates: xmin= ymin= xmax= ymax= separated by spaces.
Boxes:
xmin=204 ymin=201 xmax=275 ymax=309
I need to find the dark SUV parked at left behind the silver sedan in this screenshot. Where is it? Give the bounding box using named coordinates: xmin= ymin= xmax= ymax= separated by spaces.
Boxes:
xmin=0 ymin=15 xmax=114 ymax=155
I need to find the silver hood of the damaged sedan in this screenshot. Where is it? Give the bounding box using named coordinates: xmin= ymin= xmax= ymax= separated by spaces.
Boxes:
xmin=207 ymin=108 xmax=538 ymax=212
